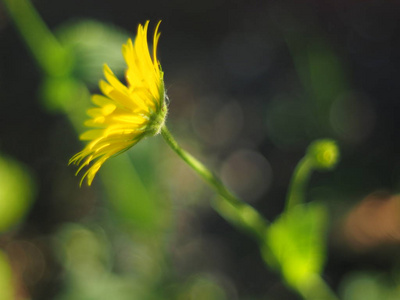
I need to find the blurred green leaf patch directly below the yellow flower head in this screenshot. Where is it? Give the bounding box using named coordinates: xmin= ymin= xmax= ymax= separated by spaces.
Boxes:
xmin=101 ymin=142 xmax=169 ymax=232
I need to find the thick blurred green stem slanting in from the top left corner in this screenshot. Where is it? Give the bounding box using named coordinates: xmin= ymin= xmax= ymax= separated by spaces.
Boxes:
xmin=3 ymin=0 xmax=70 ymax=76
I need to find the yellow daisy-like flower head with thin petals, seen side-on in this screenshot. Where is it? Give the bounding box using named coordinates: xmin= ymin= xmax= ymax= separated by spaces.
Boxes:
xmin=70 ymin=21 xmax=167 ymax=185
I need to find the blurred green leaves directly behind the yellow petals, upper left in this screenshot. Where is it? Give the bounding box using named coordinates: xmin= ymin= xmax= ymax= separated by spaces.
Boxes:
xmin=41 ymin=20 xmax=128 ymax=116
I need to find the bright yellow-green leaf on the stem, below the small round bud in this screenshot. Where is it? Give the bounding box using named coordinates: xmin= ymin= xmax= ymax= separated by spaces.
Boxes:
xmin=263 ymin=204 xmax=327 ymax=289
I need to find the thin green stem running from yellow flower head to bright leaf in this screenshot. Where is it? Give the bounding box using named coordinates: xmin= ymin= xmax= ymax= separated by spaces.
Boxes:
xmin=161 ymin=125 xmax=268 ymax=243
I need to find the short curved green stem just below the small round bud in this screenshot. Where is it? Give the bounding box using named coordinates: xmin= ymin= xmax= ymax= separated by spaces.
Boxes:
xmin=285 ymin=155 xmax=314 ymax=211
